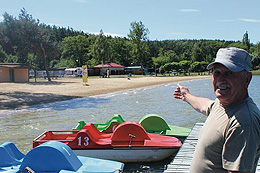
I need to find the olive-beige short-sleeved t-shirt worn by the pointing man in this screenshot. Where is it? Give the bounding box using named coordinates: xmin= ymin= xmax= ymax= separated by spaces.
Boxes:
xmin=190 ymin=97 xmax=260 ymax=173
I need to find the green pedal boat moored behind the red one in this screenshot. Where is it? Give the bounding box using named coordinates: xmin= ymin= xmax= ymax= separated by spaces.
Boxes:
xmin=73 ymin=114 xmax=191 ymax=142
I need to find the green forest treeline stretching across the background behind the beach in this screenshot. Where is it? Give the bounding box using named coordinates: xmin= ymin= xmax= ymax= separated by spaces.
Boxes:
xmin=0 ymin=8 xmax=260 ymax=80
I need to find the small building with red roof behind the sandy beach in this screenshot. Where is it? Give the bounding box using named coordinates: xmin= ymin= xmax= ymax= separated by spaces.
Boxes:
xmin=94 ymin=62 xmax=125 ymax=75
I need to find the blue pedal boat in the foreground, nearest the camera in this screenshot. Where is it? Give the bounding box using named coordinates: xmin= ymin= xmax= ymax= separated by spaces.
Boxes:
xmin=0 ymin=141 xmax=124 ymax=173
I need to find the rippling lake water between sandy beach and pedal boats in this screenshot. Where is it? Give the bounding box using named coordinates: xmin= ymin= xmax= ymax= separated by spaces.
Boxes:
xmin=0 ymin=76 xmax=260 ymax=172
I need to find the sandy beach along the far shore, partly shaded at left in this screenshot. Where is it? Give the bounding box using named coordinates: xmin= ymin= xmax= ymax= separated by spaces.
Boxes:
xmin=0 ymin=76 xmax=209 ymax=110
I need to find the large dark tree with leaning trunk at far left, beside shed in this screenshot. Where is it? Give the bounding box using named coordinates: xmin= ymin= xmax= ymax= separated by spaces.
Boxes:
xmin=0 ymin=8 xmax=54 ymax=81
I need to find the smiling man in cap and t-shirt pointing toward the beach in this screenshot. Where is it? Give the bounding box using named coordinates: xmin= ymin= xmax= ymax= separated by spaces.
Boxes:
xmin=174 ymin=47 xmax=260 ymax=173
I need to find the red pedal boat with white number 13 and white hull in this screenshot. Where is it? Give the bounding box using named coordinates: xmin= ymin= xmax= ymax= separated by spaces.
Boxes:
xmin=33 ymin=121 xmax=182 ymax=162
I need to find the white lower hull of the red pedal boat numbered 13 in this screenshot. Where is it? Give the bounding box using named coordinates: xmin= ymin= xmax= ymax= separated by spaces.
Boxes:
xmin=73 ymin=148 xmax=179 ymax=162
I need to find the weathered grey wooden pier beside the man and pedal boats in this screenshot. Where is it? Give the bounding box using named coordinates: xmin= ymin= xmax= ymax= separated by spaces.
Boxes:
xmin=164 ymin=123 xmax=260 ymax=173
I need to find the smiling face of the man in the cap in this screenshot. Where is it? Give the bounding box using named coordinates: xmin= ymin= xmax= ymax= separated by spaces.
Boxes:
xmin=212 ymin=64 xmax=251 ymax=105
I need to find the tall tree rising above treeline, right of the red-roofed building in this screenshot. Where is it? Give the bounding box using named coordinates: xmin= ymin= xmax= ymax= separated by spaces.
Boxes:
xmin=128 ymin=21 xmax=149 ymax=72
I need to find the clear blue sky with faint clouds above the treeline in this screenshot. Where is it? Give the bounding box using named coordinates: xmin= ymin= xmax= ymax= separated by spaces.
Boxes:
xmin=0 ymin=0 xmax=260 ymax=44
